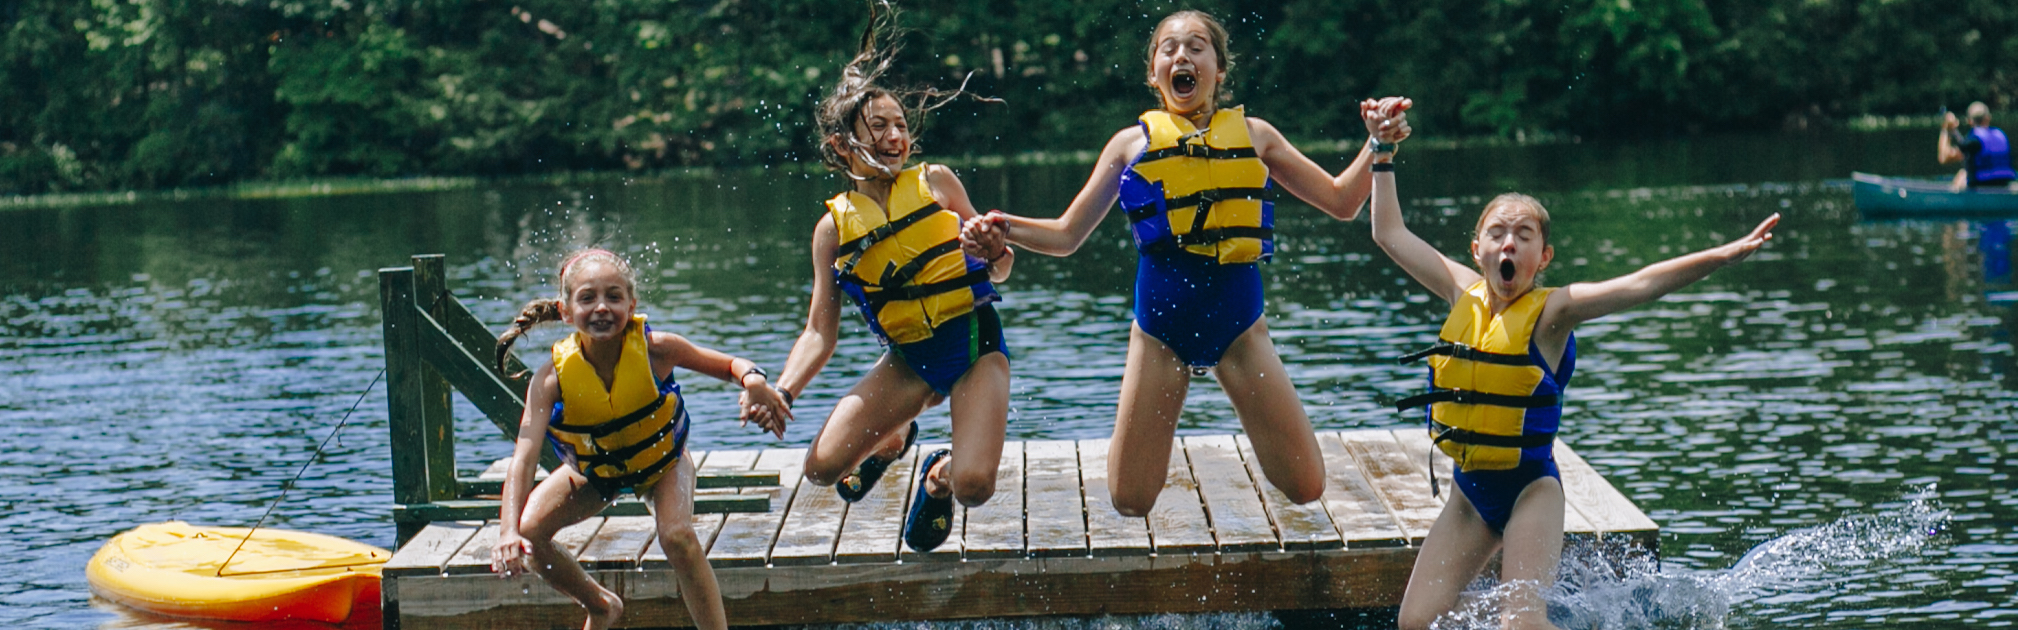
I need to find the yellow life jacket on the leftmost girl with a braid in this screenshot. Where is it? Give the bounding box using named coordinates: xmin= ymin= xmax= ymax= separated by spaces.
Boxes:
xmin=547 ymin=315 xmax=688 ymax=495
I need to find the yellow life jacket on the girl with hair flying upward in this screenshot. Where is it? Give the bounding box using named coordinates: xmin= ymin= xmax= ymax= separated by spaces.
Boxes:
xmin=827 ymin=164 xmax=999 ymax=343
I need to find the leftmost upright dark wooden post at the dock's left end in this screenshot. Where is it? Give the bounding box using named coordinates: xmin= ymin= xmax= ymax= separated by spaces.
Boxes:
xmin=379 ymin=267 xmax=432 ymax=543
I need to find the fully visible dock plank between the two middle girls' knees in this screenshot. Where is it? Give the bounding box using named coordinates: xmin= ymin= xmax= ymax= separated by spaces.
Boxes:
xmin=1023 ymin=440 xmax=1086 ymax=557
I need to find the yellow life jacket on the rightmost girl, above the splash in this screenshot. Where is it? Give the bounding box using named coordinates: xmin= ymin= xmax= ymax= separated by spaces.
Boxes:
xmin=1394 ymin=281 xmax=1576 ymax=470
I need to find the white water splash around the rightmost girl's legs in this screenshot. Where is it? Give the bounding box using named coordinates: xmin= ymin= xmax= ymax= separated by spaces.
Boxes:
xmin=1433 ymin=487 xmax=1949 ymax=630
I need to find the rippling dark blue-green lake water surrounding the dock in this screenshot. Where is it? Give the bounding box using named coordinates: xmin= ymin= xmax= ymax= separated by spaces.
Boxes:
xmin=0 ymin=131 xmax=2018 ymax=628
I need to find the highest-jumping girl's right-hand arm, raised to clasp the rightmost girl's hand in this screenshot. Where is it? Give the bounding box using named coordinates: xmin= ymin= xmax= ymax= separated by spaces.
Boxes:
xmin=1247 ymin=97 xmax=1415 ymax=220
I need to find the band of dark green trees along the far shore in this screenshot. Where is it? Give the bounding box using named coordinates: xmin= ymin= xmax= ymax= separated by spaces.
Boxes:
xmin=0 ymin=0 xmax=2018 ymax=194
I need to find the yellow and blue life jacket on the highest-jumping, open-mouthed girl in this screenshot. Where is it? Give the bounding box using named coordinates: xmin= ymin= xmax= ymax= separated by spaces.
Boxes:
xmin=1120 ymin=107 xmax=1275 ymax=265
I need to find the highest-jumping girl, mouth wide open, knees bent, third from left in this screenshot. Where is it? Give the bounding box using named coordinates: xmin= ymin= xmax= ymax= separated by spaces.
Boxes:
xmin=967 ymin=10 xmax=1409 ymax=517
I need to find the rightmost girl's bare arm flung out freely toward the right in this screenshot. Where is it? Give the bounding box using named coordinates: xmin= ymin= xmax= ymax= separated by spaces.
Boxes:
xmin=1540 ymin=212 xmax=1780 ymax=333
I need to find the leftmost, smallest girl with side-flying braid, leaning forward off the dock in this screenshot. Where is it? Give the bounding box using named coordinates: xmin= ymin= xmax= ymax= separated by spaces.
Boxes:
xmin=490 ymin=250 xmax=785 ymax=630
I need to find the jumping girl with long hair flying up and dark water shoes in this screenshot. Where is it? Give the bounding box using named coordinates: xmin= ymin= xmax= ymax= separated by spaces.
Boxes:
xmin=779 ymin=4 xmax=1015 ymax=551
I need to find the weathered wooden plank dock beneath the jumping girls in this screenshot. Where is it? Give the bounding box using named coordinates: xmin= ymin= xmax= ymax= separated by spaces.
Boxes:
xmin=383 ymin=428 xmax=1659 ymax=628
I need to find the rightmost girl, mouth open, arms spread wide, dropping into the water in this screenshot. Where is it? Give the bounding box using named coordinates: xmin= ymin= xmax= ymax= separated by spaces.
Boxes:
xmin=1360 ymin=119 xmax=1780 ymax=628
